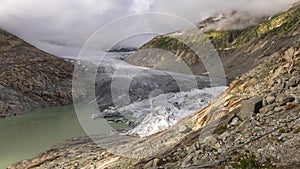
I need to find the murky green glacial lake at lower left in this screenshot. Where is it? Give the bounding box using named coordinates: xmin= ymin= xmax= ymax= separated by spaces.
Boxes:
xmin=0 ymin=105 xmax=127 ymax=169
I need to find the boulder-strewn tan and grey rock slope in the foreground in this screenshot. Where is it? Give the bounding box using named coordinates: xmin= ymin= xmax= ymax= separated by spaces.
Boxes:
xmin=10 ymin=2 xmax=300 ymax=169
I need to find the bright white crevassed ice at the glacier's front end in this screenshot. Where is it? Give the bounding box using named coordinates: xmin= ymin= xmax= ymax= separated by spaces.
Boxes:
xmin=98 ymin=86 xmax=227 ymax=137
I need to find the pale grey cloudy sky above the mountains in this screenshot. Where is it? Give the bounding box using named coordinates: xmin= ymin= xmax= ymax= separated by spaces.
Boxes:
xmin=0 ymin=0 xmax=297 ymax=56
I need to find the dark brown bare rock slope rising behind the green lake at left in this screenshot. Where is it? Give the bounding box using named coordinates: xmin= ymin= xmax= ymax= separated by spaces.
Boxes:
xmin=0 ymin=30 xmax=73 ymax=117
